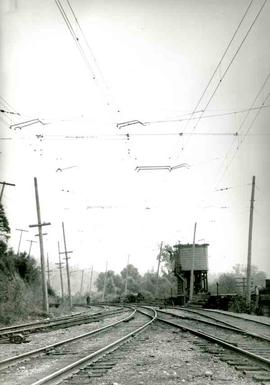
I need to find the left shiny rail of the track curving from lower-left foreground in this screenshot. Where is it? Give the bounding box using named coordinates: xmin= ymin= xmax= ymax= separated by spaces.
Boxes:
xmin=0 ymin=309 xmax=136 ymax=369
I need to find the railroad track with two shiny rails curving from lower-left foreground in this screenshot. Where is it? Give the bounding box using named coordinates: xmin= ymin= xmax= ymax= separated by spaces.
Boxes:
xmin=0 ymin=309 xmax=156 ymax=385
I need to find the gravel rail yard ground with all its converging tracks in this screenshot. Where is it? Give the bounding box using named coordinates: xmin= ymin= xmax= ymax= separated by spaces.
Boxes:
xmin=0 ymin=306 xmax=270 ymax=385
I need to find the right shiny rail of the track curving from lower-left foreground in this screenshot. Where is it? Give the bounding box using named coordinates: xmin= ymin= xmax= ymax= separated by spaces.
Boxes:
xmin=31 ymin=309 xmax=157 ymax=385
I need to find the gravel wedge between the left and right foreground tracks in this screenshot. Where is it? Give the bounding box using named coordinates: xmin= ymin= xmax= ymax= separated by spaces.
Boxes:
xmin=86 ymin=324 xmax=258 ymax=385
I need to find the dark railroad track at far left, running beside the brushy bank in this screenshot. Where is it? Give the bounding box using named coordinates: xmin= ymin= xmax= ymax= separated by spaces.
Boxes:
xmin=0 ymin=307 xmax=124 ymax=343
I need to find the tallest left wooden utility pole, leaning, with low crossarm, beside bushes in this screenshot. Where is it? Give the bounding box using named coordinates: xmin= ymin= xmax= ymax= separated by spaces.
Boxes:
xmin=29 ymin=177 xmax=50 ymax=313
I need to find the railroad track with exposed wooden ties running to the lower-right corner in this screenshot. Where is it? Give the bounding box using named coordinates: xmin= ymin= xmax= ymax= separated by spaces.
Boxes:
xmin=157 ymin=310 xmax=270 ymax=383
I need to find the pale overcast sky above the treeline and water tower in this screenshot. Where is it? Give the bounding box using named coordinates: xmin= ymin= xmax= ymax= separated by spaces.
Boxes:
xmin=0 ymin=0 xmax=270 ymax=277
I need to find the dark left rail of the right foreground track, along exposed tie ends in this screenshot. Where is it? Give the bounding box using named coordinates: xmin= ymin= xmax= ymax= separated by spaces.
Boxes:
xmin=157 ymin=317 xmax=270 ymax=368
